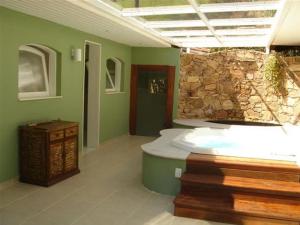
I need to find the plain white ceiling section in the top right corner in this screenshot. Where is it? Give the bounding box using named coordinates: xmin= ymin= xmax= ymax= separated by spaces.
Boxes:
xmin=272 ymin=0 xmax=300 ymax=46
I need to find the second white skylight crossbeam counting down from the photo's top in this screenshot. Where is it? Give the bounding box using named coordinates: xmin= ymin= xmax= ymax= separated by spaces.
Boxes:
xmin=144 ymin=17 xmax=273 ymax=28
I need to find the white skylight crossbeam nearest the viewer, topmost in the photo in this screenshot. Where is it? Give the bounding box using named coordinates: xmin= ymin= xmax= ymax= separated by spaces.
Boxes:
xmin=122 ymin=1 xmax=279 ymax=16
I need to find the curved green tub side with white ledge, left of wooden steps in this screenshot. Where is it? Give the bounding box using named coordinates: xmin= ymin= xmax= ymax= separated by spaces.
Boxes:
xmin=141 ymin=129 xmax=189 ymax=196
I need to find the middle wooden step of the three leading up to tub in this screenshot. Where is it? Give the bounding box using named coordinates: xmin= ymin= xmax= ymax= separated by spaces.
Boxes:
xmin=181 ymin=173 xmax=300 ymax=198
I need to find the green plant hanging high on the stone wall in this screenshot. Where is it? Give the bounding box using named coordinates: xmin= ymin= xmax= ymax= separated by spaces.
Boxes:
xmin=263 ymin=54 xmax=284 ymax=93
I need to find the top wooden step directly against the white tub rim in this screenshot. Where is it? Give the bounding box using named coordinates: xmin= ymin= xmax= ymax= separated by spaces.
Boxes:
xmin=187 ymin=153 xmax=300 ymax=176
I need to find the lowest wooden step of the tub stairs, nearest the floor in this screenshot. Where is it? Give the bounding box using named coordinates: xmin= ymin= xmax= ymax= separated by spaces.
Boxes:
xmin=174 ymin=194 xmax=300 ymax=224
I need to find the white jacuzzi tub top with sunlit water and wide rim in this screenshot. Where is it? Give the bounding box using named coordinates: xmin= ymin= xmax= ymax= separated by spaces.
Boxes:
xmin=142 ymin=125 xmax=300 ymax=165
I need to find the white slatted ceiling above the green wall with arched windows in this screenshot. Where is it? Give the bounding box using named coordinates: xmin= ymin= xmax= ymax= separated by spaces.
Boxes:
xmin=0 ymin=0 xmax=170 ymax=47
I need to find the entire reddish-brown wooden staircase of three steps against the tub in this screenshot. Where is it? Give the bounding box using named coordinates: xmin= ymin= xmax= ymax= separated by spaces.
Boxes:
xmin=174 ymin=153 xmax=300 ymax=225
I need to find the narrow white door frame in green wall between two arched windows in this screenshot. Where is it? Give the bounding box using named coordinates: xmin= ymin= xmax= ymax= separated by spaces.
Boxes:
xmin=81 ymin=40 xmax=102 ymax=153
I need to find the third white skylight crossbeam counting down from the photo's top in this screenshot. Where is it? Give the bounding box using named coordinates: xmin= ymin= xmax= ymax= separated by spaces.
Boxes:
xmin=160 ymin=28 xmax=271 ymax=37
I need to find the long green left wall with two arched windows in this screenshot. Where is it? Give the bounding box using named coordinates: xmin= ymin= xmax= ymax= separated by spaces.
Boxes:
xmin=0 ymin=7 xmax=131 ymax=182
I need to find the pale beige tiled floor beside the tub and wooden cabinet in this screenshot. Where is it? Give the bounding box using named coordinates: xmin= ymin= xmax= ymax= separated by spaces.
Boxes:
xmin=0 ymin=136 xmax=227 ymax=225
